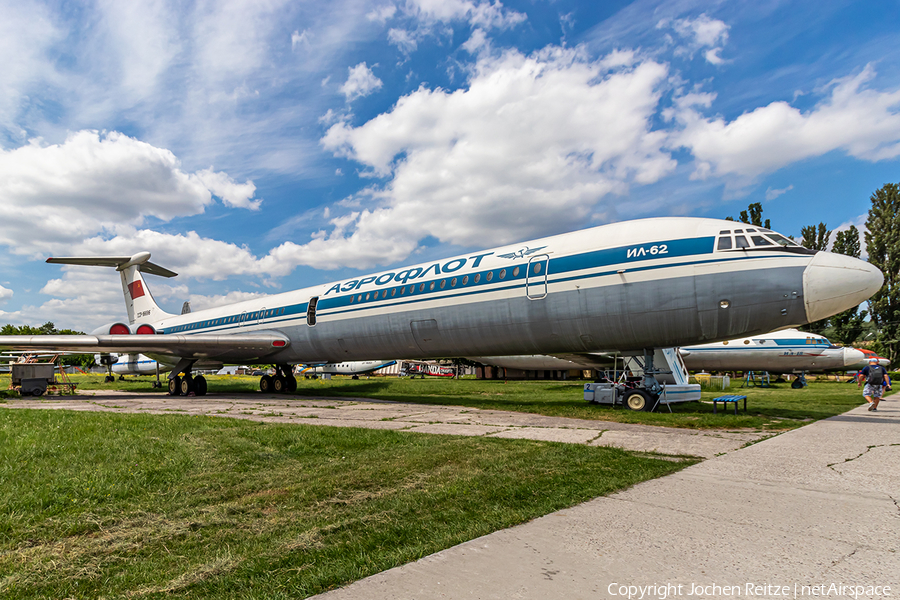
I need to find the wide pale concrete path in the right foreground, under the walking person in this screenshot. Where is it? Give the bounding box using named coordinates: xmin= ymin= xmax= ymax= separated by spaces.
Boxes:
xmin=312 ymin=398 xmax=900 ymax=600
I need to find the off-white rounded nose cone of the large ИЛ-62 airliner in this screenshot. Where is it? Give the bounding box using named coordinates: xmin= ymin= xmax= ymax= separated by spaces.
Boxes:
xmin=803 ymin=252 xmax=884 ymax=323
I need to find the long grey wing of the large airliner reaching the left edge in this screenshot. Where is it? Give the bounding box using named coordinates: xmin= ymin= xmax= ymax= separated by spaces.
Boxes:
xmin=0 ymin=331 xmax=291 ymax=362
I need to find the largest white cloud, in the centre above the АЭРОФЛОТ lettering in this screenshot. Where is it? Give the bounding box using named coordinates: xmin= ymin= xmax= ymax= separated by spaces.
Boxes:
xmin=312 ymin=47 xmax=675 ymax=265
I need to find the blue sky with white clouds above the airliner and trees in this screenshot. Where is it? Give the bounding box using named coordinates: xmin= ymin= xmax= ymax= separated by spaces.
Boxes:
xmin=0 ymin=0 xmax=900 ymax=330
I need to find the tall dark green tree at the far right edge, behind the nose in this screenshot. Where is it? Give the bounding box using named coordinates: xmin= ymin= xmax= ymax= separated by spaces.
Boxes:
xmin=866 ymin=183 xmax=900 ymax=363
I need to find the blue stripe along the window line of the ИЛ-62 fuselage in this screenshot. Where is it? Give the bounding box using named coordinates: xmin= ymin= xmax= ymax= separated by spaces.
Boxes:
xmin=163 ymin=236 xmax=811 ymax=336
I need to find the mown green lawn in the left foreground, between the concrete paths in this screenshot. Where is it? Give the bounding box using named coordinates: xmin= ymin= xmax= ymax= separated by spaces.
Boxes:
xmin=0 ymin=408 xmax=690 ymax=599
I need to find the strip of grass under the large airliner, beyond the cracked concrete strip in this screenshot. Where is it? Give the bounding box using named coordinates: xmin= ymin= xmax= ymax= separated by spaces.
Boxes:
xmin=0 ymin=376 xmax=880 ymax=431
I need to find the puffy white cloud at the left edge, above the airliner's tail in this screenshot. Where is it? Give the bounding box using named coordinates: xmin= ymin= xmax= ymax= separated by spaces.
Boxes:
xmin=0 ymin=131 xmax=259 ymax=255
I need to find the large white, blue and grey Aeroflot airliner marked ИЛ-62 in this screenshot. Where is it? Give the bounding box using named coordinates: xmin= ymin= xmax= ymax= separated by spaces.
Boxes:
xmin=0 ymin=218 xmax=883 ymax=400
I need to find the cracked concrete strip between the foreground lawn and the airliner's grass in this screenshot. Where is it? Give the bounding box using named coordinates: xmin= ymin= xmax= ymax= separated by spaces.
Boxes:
xmin=0 ymin=391 xmax=767 ymax=458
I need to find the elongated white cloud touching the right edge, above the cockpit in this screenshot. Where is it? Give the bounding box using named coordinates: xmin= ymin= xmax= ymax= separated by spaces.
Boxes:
xmin=672 ymin=65 xmax=900 ymax=180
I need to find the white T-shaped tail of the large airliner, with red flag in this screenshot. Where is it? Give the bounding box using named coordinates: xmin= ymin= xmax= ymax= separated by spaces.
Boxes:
xmin=47 ymin=252 xmax=177 ymax=324
